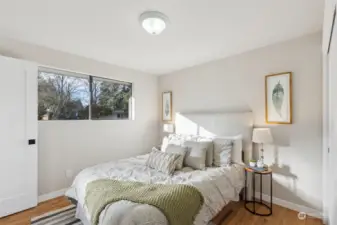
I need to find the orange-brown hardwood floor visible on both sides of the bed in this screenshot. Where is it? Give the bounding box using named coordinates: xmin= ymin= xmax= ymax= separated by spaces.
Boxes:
xmin=0 ymin=197 xmax=322 ymax=225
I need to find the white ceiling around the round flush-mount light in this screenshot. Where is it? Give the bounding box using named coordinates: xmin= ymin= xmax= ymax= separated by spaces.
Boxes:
xmin=0 ymin=0 xmax=324 ymax=75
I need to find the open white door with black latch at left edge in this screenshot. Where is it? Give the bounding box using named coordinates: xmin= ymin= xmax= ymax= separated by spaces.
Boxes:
xmin=0 ymin=56 xmax=37 ymax=217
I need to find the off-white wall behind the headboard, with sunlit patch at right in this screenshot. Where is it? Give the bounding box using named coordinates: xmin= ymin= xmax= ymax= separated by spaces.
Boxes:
xmin=159 ymin=33 xmax=322 ymax=211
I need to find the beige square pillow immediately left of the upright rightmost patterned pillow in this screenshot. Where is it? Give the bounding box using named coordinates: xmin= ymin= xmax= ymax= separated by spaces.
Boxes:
xmin=184 ymin=141 xmax=208 ymax=170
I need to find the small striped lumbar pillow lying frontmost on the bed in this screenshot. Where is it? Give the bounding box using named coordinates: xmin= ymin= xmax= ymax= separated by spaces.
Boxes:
xmin=145 ymin=150 xmax=178 ymax=175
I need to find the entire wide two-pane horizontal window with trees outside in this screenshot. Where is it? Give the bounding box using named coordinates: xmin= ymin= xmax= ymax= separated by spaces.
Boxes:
xmin=38 ymin=68 xmax=132 ymax=120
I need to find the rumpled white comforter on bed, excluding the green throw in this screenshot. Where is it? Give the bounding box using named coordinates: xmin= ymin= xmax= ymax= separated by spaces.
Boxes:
xmin=66 ymin=155 xmax=244 ymax=225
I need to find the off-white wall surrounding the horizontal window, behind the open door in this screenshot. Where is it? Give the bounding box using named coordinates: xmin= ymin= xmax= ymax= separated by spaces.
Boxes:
xmin=0 ymin=39 xmax=159 ymax=195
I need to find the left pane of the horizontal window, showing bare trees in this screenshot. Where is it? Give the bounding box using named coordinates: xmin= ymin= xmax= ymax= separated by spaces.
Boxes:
xmin=38 ymin=71 xmax=90 ymax=120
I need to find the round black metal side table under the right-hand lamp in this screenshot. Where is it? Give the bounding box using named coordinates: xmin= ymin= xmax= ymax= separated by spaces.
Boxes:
xmin=245 ymin=167 xmax=273 ymax=216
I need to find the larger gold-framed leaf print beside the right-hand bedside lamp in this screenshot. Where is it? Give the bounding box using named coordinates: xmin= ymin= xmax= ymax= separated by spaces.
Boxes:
xmin=265 ymin=72 xmax=293 ymax=124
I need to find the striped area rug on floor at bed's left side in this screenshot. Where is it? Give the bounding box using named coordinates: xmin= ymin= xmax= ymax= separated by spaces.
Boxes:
xmin=31 ymin=205 xmax=82 ymax=225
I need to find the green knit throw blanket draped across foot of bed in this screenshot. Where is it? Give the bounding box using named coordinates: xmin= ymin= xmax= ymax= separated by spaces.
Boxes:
xmin=85 ymin=179 xmax=204 ymax=225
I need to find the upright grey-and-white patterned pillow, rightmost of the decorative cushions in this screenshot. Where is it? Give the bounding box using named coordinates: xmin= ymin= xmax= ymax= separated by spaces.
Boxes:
xmin=213 ymin=138 xmax=233 ymax=166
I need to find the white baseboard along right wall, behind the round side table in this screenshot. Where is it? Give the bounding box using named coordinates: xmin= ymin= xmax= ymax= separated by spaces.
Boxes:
xmin=255 ymin=192 xmax=323 ymax=219
